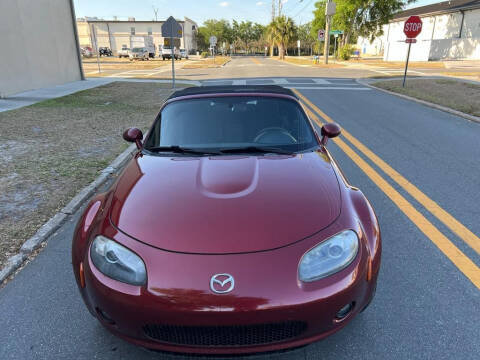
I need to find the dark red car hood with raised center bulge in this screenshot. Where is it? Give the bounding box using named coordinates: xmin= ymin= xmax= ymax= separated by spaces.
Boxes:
xmin=110 ymin=151 xmax=341 ymax=254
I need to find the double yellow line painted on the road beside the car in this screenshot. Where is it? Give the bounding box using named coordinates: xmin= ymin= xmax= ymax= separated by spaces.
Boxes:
xmin=293 ymin=89 xmax=480 ymax=289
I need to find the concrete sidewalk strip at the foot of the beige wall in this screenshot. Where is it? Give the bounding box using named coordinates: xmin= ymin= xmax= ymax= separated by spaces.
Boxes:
xmin=0 ymin=78 xmax=113 ymax=112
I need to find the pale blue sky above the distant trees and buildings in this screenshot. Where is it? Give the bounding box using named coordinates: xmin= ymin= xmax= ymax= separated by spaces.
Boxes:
xmin=74 ymin=0 xmax=439 ymax=25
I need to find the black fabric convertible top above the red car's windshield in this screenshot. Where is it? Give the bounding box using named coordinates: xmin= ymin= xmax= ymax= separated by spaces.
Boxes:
xmin=168 ymin=85 xmax=298 ymax=99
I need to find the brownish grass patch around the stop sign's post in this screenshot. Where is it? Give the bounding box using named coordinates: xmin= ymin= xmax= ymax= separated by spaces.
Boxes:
xmin=372 ymin=78 xmax=480 ymax=116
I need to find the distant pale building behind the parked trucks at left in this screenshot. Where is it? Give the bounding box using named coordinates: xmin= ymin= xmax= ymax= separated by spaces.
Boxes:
xmin=77 ymin=17 xmax=198 ymax=55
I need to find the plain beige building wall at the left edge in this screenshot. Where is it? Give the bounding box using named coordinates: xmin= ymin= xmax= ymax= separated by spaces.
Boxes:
xmin=0 ymin=0 xmax=82 ymax=97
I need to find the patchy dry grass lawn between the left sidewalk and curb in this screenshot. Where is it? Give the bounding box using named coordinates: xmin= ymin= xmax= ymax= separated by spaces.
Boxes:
xmin=0 ymin=82 xmax=190 ymax=268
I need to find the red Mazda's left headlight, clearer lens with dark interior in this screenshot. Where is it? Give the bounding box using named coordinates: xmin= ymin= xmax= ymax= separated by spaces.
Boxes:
xmin=90 ymin=235 xmax=147 ymax=285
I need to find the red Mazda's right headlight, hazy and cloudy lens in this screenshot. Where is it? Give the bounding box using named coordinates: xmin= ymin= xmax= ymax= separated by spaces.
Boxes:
xmin=298 ymin=230 xmax=358 ymax=282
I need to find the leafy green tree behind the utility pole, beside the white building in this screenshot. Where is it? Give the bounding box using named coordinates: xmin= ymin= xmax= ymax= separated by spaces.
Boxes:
xmin=312 ymin=0 xmax=416 ymax=44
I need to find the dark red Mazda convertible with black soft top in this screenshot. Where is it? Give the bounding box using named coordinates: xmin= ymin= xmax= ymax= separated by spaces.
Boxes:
xmin=72 ymin=86 xmax=381 ymax=353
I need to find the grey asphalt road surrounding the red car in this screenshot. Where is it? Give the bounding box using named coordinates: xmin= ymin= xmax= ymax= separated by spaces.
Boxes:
xmin=0 ymin=58 xmax=480 ymax=359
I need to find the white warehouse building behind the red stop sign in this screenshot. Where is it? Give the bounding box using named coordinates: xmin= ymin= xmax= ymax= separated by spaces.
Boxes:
xmin=357 ymin=0 xmax=480 ymax=61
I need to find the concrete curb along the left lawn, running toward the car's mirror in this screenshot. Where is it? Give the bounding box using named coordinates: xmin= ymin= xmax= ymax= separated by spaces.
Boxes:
xmin=0 ymin=144 xmax=136 ymax=285
